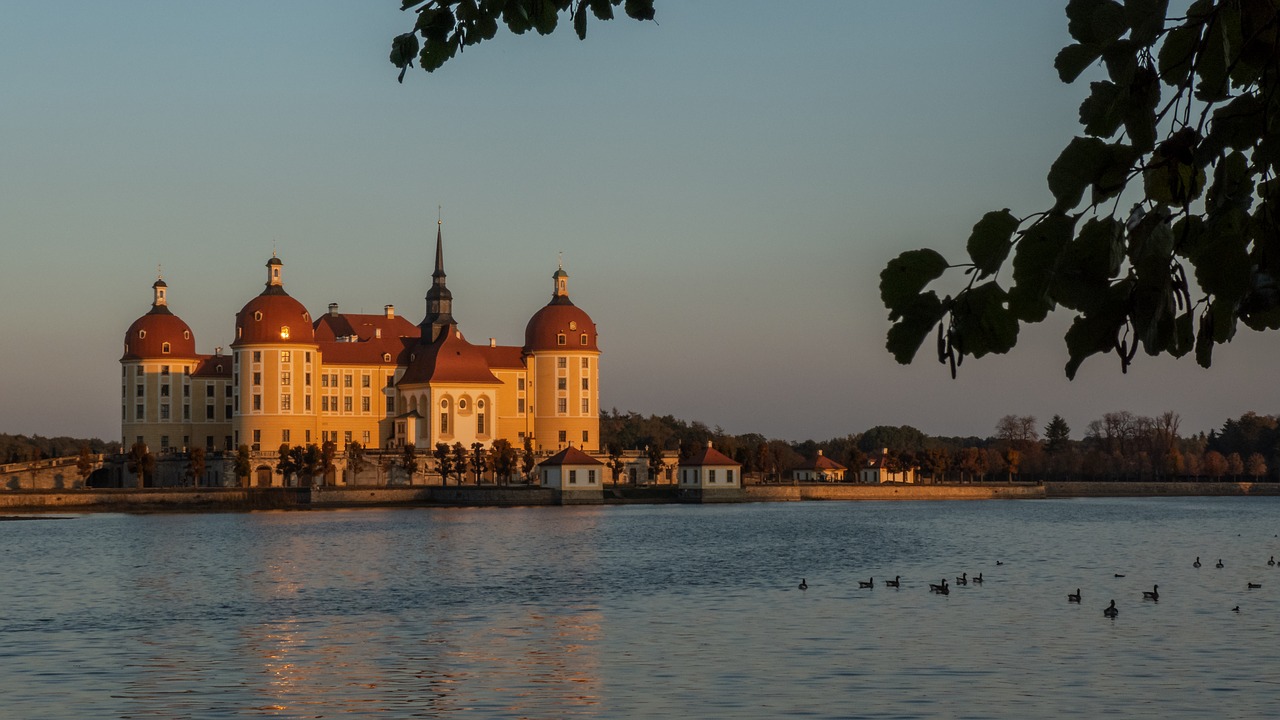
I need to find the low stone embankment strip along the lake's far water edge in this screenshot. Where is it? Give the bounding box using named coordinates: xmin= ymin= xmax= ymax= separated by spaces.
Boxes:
xmin=0 ymin=482 xmax=1280 ymax=512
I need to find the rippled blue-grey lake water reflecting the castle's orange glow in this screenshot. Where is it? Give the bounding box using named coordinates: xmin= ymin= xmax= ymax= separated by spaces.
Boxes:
xmin=0 ymin=498 xmax=1280 ymax=719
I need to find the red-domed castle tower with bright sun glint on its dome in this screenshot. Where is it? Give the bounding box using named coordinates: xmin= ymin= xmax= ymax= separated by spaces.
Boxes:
xmin=232 ymin=254 xmax=318 ymax=451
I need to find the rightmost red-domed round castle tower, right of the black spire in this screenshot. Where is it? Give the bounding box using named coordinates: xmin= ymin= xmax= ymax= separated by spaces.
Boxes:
xmin=524 ymin=260 xmax=600 ymax=452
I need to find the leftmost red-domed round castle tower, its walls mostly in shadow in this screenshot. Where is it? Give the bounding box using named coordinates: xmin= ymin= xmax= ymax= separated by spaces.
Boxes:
xmin=120 ymin=278 xmax=198 ymax=452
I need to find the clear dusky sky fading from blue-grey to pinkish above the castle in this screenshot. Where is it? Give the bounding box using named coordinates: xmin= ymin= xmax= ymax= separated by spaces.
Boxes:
xmin=0 ymin=0 xmax=1280 ymax=441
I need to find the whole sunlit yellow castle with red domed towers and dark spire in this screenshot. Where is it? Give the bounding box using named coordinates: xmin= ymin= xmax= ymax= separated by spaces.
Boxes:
xmin=120 ymin=224 xmax=600 ymax=454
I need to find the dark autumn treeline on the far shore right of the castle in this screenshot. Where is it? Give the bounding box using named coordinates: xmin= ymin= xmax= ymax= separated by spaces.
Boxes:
xmin=600 ymin=409 xmax=1280 ymax=482
